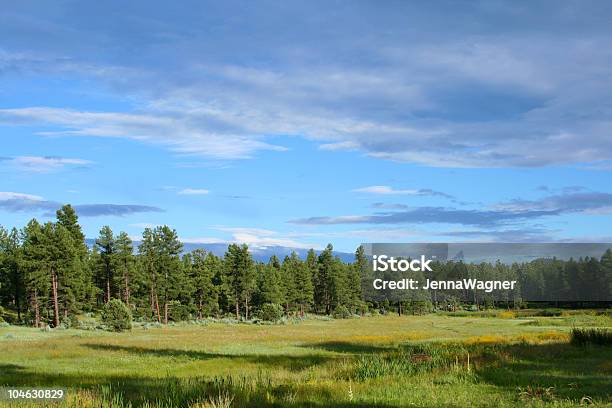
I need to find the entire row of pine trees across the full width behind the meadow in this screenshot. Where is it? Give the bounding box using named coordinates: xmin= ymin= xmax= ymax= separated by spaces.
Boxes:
xmin=0 ymin=205 xmax=612 ymax=327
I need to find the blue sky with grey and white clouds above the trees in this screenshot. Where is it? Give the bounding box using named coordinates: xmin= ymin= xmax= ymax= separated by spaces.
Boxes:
xmin=0 ymin=1 xmax=612 ymax=251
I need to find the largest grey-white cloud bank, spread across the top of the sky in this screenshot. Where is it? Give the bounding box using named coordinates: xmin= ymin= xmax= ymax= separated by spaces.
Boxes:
xmin=0 ymin=2 xmax=612 ymax=167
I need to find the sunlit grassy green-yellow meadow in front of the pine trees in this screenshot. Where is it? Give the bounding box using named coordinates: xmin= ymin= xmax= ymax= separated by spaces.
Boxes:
xmin=0 ymin=312 xmax=612 ymax=407
